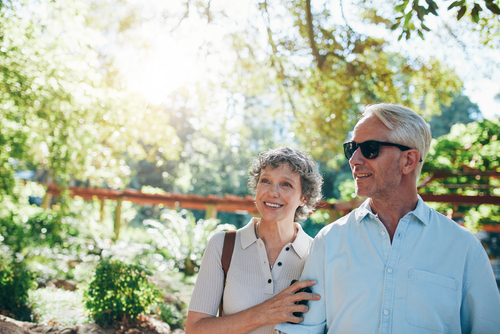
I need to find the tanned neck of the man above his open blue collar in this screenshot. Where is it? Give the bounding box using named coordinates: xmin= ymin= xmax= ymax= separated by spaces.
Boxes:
xmin=370 ymin=191 xmax=418 ymax=242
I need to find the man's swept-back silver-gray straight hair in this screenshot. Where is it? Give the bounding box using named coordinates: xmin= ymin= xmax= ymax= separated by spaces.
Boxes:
xmin=361 ymin=103 xmax=432 ymax=181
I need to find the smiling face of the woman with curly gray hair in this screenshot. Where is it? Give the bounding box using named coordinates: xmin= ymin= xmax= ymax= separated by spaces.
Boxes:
xmin=255 ymin=164 xmax=306 ymax=222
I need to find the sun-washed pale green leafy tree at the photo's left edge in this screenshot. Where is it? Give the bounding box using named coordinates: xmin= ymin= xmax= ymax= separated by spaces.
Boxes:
xmin=0 ymin=0 xmax=180 ymax=195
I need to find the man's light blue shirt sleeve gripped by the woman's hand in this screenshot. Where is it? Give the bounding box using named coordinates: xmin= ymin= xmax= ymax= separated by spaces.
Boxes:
xmin=275 ymin=235 xmax=327 ymax=334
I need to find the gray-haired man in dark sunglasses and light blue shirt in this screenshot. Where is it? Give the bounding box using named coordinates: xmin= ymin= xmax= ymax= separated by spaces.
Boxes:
xmin=276 ymin=104 xmax=500 ymax=334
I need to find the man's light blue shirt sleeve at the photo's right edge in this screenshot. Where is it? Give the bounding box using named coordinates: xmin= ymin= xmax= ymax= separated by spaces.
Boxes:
xmin=460 ymin=242 xmax=500 ymax=334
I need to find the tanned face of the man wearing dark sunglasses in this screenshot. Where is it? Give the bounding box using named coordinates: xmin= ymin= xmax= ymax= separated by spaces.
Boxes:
xmin=349 ymin=115 xmax=402 ymax=200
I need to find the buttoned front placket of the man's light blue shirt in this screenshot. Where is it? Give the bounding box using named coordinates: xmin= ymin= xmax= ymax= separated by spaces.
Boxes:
xmin=380 ymin=219 xmax=409 ymax=334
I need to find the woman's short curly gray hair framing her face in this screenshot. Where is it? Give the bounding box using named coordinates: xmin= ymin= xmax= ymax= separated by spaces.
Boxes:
xmin=248 ymin=147 xmax=323 ymax=222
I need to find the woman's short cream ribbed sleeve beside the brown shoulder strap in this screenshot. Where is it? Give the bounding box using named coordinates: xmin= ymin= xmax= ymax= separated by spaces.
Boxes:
xmin=189 ymin=232 xmax=225 ymax=316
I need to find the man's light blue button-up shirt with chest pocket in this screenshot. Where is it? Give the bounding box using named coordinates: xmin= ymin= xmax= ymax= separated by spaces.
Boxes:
xmin=276 ymin=197 xmax=500 ymax=334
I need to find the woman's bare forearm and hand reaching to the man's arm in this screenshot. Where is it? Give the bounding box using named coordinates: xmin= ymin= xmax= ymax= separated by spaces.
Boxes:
xmin=186 ymin=280 xmax=321 ymax=334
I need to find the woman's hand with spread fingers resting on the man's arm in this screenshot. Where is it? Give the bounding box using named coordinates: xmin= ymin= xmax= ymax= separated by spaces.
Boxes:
xmin=252 ymin=280 xmax=321 ymax=325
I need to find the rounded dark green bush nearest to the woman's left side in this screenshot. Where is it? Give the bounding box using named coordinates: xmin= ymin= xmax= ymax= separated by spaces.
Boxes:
xmin=84 ymin=260 xmax=161 ymax=325
